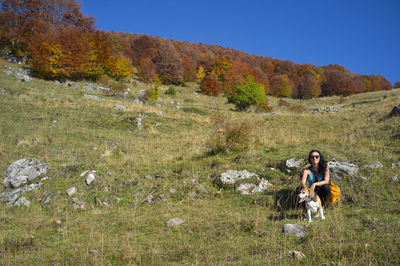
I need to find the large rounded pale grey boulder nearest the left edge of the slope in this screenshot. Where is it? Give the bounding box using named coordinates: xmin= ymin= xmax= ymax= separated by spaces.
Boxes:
xmin=4 ymin=158 xmax=50 ymax=188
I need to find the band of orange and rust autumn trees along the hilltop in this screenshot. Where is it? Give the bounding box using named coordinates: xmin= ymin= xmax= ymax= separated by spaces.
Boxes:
xmin=0 ymin=0 xmax=392 ymax=99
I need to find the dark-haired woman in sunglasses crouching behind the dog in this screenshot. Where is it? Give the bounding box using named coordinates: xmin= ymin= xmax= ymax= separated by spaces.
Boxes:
xmin=301 ymin=150 xmax=331 ymax=206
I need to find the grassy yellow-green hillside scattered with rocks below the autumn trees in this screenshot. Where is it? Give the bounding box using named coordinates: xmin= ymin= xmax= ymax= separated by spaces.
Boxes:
xmin=0 ymin=60 xmax=400 ymax=265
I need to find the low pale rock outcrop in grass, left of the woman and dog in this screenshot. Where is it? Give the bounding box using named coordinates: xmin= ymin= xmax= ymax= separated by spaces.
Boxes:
xmin=215 ymin=170 xmax=272 ymax=195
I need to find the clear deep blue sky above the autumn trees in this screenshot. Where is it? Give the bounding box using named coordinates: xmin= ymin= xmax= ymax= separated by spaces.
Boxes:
xmin=78 ymin=0 xmax=400 ymax=83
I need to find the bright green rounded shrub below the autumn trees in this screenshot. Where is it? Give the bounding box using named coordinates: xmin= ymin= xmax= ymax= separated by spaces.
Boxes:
xmin=228 ymin=81 xmax=265 ymax=110
